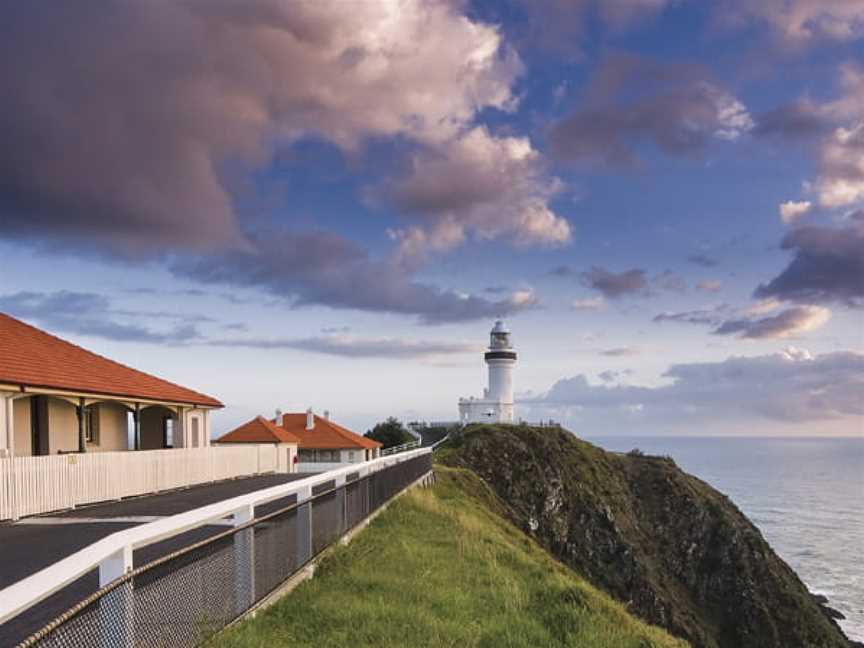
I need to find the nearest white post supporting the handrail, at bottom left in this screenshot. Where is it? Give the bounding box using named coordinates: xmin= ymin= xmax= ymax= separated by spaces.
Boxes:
xmin=99 ymin=545 xmax=135 ymax=648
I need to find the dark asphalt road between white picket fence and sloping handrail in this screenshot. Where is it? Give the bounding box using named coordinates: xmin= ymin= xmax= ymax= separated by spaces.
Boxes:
xmin=0 ymin=474 xmax=309 ymax=646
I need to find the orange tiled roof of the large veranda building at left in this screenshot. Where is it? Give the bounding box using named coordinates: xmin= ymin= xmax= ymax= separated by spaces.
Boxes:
xmin=0 ymin=313 xmax=222 ymax=407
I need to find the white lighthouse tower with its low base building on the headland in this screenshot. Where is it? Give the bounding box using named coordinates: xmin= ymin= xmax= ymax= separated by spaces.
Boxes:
xmin=459 ymin=320 xmax=516 ymax=424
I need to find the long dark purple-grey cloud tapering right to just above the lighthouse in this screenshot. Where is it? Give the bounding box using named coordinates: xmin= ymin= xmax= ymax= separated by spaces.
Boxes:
xmin=172 ymin=231 xmax=537 ymax=324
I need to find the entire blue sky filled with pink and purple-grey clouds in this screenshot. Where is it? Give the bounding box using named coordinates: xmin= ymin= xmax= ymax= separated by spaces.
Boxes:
xmin=0 ymin=0 xmax=864 ymax=436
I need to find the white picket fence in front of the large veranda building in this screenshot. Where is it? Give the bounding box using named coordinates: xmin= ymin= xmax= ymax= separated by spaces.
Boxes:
xmin=0 ymin=445 xmax=285 ymax=520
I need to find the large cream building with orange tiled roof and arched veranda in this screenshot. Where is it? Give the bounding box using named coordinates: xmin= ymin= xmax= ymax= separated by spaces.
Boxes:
xmin=0 ymin=313 xmax=222 ymax=457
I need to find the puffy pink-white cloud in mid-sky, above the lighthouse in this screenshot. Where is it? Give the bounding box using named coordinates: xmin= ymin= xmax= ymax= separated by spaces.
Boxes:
xmin=382 ymin=126 xmax=571 ymax=257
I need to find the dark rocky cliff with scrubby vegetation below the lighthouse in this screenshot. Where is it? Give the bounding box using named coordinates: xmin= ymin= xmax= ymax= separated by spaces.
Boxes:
xmin=440 ymin=425 xmax=850 ymax=648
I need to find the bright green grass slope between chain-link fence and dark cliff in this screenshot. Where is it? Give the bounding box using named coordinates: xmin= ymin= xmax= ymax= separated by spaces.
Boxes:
xmin=214 ymin=468 xmax=687 ymax=648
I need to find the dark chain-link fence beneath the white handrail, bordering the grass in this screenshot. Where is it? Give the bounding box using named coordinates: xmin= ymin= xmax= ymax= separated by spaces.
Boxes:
xmin=20 ymin=453 xmax=432 ymax=648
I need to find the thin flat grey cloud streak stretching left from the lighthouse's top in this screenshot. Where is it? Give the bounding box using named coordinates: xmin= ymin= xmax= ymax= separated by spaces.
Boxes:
xmin=207 ymin=335 xmax=482 ymax=360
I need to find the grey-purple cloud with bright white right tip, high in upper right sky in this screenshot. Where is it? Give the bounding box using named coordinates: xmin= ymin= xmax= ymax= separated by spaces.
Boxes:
xmin=550 ymin=54 xmax=755 ymax=166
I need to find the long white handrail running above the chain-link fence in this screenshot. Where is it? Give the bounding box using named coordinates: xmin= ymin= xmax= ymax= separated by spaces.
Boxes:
xmin=0 ymin=448 xmax=431 ymax=624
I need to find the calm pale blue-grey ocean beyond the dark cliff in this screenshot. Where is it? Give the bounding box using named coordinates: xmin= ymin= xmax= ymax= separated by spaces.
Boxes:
xmin=588 ymin=437 xmax=864 ymax=641
